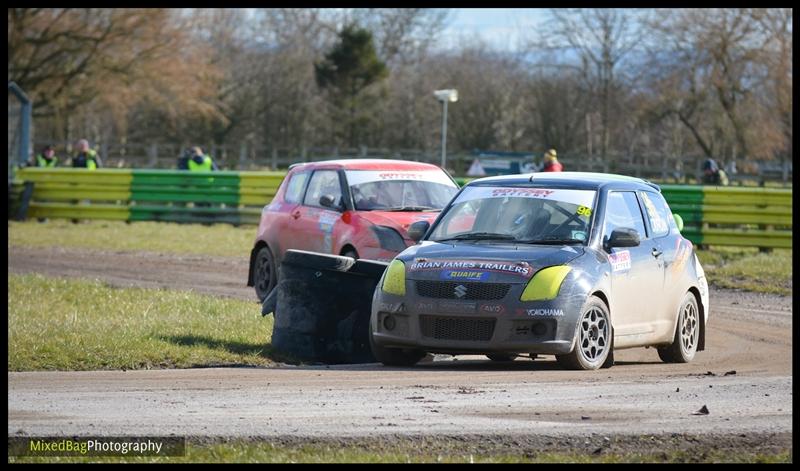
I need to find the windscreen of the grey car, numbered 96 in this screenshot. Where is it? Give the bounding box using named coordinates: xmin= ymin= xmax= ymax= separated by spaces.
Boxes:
xmin=429 ymin=186 xmax=597 ymax=244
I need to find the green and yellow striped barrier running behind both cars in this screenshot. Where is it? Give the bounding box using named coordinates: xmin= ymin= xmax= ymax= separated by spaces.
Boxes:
xmin=9 ymin=168 xmax=793 ymax=248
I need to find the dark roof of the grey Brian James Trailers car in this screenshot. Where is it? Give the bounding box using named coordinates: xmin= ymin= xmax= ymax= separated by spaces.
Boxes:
xmin=469 ymin=172 xmax=661 ymax=191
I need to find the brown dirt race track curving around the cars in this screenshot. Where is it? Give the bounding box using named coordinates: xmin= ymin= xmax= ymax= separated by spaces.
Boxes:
xmin=8 ymin=247 xmax=792 ymax=443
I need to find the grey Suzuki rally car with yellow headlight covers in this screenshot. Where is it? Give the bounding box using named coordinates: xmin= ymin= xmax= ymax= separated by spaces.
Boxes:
xmin=370 ymin=172 xmax=709 ymax=370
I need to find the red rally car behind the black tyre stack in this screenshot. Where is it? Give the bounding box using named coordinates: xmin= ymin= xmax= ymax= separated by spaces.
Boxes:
xmin=247 ymin=159 xmax=458 ymax=300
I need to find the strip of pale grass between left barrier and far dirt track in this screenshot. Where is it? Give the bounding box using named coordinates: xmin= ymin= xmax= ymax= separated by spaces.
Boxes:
xmin=8 ymin=219 xmax=257 ymax=257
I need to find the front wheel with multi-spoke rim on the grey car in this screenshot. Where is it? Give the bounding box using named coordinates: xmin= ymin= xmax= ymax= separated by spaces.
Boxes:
xmin=556 ymin=296 xmax=613 ymax=370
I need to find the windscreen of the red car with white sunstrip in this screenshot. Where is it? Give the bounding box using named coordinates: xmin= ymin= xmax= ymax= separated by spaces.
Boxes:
xmin=346 ymin=170 xmax=458 ymax=211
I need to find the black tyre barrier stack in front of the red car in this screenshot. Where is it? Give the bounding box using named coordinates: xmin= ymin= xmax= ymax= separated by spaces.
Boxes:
xmin=261 ymin=250 xmax=389 ymax=364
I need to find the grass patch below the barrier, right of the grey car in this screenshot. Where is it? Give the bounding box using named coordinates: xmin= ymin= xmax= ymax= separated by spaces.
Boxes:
xmin=697 ymin=247 xmax=792 ymax=296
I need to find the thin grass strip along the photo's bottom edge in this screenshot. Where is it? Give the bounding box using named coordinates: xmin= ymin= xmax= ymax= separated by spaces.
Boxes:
xmin=9 ymin=439 xmax=792 ymax=463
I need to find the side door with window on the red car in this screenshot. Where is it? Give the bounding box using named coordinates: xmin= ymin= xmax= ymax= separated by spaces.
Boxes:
xmin=292 ymin=170 xmax=342 ymax=253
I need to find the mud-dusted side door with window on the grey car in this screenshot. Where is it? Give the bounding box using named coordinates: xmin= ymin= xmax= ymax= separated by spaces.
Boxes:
xmin=602 ymin=191 xmax=663 ymax=347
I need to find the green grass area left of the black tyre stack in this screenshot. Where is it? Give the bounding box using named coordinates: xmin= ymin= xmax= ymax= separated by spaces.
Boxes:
xmin=8 ymin=274 xmax=274 ymax=371
